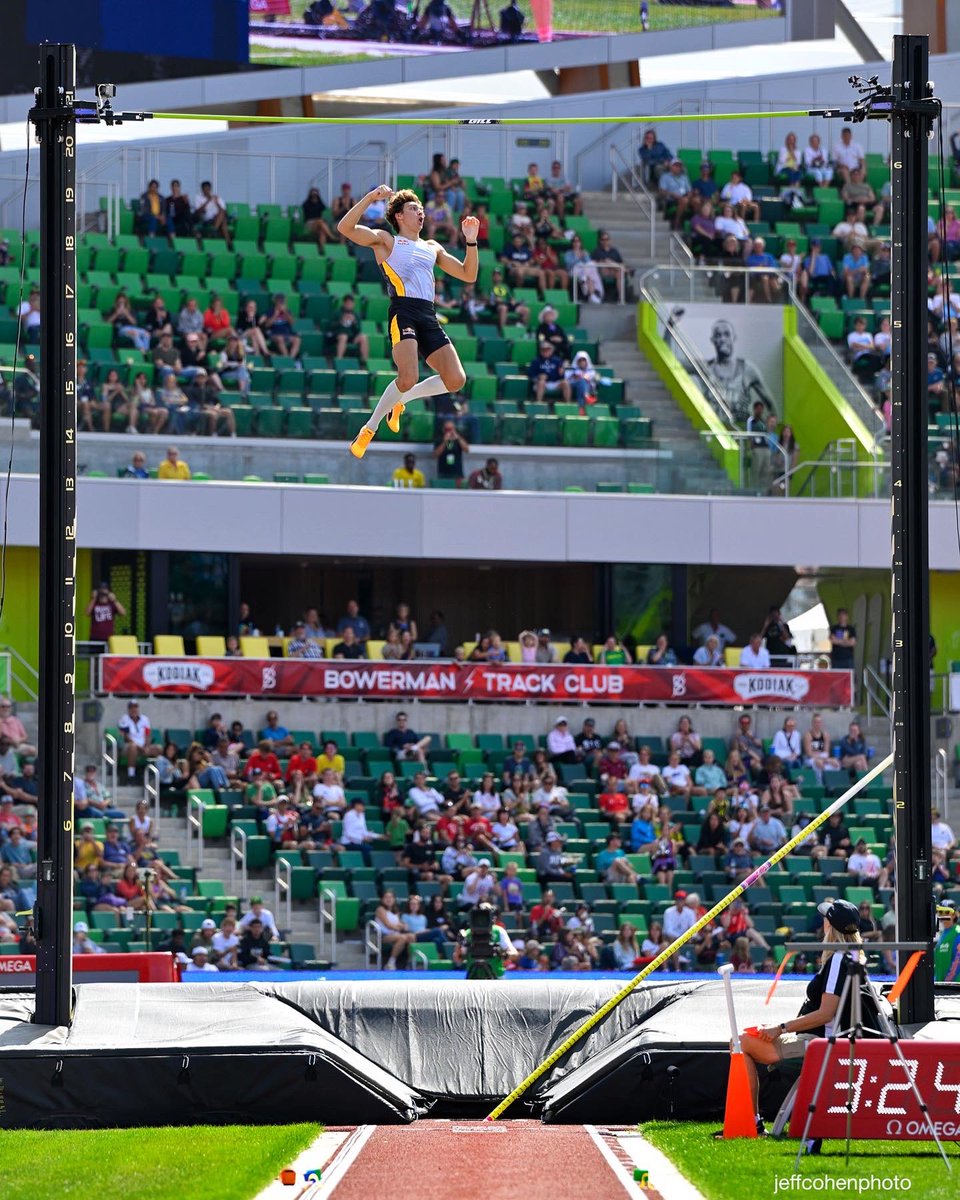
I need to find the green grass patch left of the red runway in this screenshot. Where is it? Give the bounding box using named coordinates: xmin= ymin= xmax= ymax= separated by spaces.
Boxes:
xmin=0 ymin=1124 xmax=323 ymax=1200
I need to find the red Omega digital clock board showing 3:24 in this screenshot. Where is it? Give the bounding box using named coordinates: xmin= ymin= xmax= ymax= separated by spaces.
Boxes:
xmin=790 ymin=1038 xmax=960 ymax=1141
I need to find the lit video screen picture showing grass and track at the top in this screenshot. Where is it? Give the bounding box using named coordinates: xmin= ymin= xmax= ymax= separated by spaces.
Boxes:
xmin=250 ymin=0 xmax=782 ymax=67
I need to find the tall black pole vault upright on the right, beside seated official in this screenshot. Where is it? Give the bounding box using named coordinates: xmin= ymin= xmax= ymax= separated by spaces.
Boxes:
xmin=890 ymin=35 xmax=935 ymax=1024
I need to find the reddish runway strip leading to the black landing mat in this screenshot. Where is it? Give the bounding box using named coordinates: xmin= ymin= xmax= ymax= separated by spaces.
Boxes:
xmin=332 ymin=1121 xmax=628 ymax=1200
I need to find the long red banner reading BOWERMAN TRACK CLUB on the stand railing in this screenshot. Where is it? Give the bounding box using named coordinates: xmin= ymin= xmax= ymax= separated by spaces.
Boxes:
xmin=100 ymin=654 xmax=853 ymax=708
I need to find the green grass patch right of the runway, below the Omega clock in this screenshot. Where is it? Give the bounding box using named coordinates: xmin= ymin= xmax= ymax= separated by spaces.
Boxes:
xmin=641 ymin=1121 xmax=960 ymax=1200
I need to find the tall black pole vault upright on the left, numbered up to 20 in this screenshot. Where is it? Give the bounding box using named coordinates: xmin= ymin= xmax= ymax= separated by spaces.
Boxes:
xmin=30 ymin=46 xmax=77 ymax=1025
